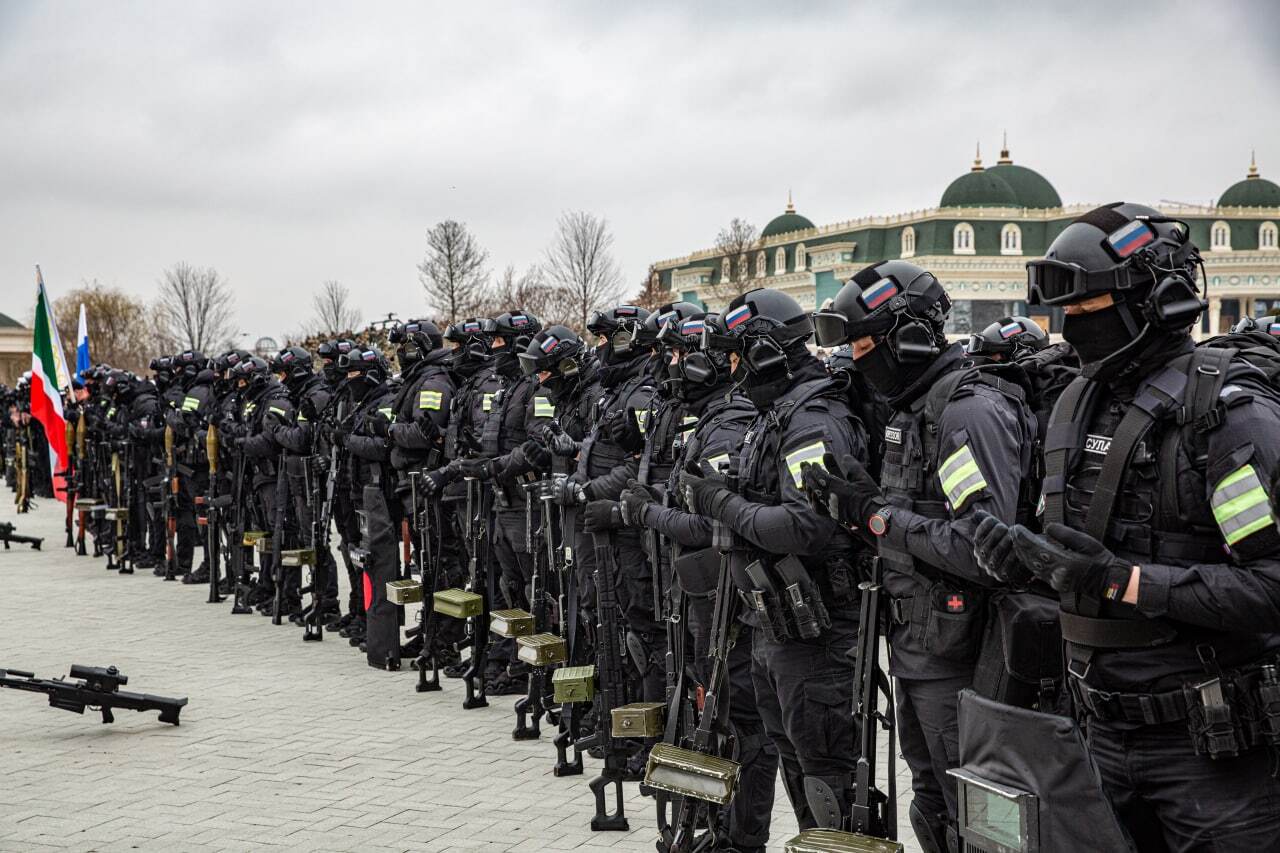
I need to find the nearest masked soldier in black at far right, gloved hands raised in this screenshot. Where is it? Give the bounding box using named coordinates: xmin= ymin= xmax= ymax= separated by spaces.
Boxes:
xmin=982 ymin=202 xmax=1280 ymax=852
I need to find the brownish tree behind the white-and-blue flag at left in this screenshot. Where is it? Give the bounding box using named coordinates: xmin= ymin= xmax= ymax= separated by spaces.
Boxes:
xmin=54 ymin=279 xmax=152 ymax=373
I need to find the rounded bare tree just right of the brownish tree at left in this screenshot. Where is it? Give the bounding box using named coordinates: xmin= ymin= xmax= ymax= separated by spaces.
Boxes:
xmin=155 ymin=261 xmax=237 ymax=352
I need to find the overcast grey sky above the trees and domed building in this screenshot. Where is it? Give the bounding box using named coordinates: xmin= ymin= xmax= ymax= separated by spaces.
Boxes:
xmin=0 ymin=0 xmax=1280 ymax=338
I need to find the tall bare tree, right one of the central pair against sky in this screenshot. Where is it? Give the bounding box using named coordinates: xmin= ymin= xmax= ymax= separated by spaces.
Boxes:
xmin=545 ymin=210 xmax=622 ymax=332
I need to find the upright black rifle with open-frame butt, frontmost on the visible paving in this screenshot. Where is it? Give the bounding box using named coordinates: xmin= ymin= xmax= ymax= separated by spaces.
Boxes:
xmin=579 ymin=533 xmax=630 ymax=833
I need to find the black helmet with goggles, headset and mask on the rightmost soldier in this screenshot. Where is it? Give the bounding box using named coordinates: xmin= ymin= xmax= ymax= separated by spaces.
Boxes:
xmin=1027 ymin=202 xmax=1207 ymax=378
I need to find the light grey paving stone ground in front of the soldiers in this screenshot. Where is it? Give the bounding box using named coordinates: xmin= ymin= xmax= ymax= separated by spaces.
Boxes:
xmin=0 ymin=492 xmax=918 ymax=853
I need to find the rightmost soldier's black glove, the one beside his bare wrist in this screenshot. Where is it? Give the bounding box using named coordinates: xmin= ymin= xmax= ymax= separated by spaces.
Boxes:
xmin=1011 ymin=523 xmax=1133 ymax=601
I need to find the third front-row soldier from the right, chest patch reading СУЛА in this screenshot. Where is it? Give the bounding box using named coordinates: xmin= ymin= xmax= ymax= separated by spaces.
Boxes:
xmin=680 ymin=289 xmax=867 ymax=827
